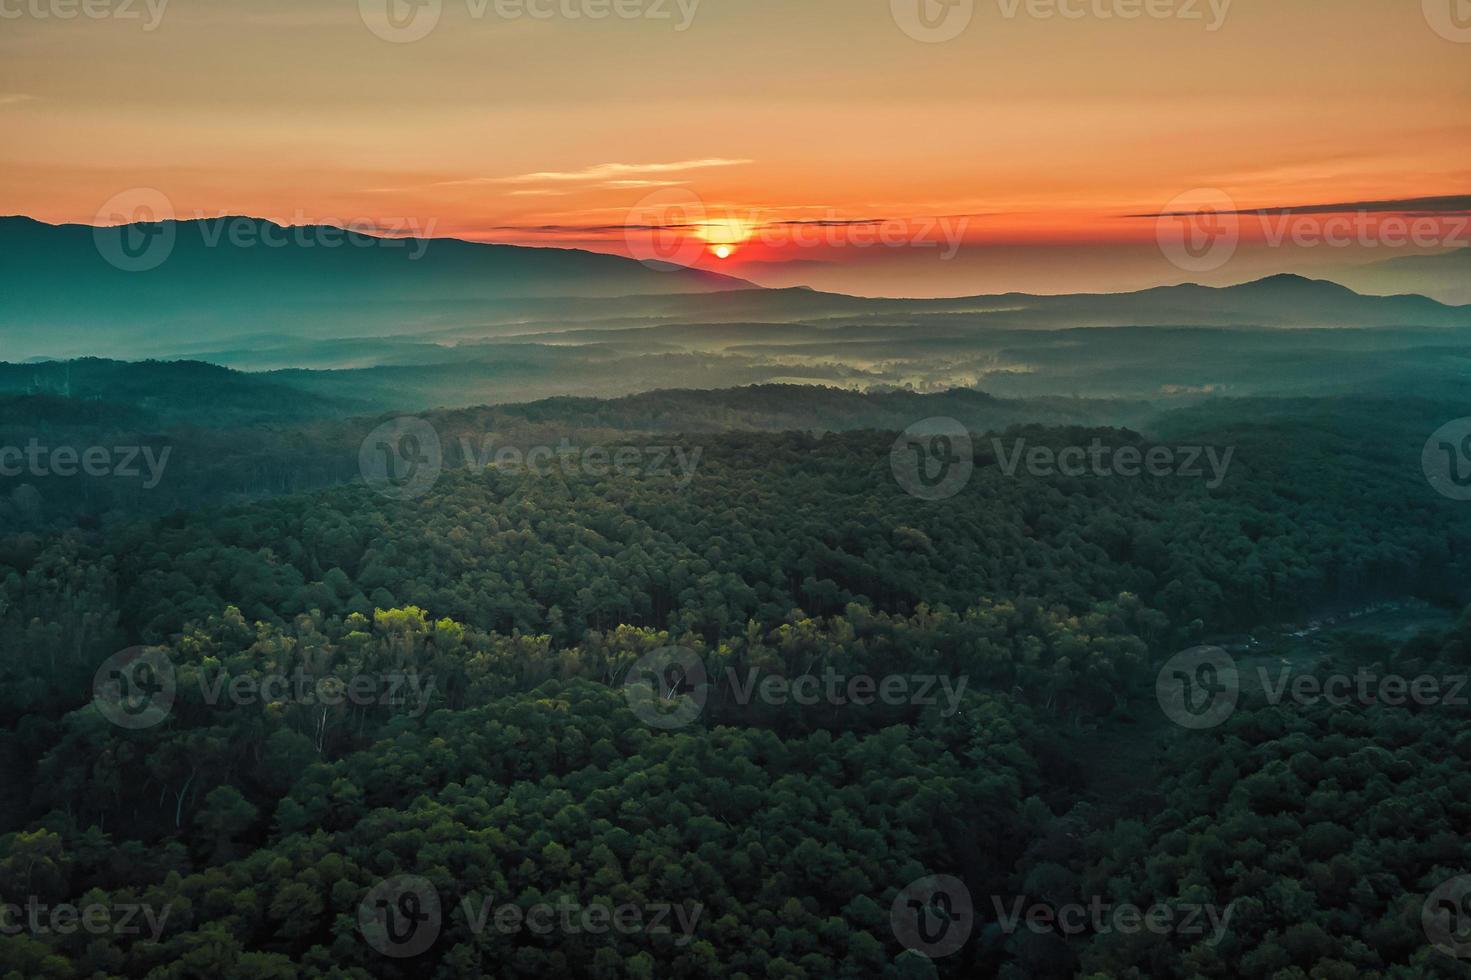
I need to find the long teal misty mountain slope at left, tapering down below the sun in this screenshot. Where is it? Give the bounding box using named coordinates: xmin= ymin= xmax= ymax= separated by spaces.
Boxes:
xmin=0 ymin=218 xmax=756 ymax=359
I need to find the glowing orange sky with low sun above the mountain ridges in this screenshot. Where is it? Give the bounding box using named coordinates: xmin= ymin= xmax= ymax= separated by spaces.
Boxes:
xmin=0 ymin=0 xmax=1471 ymax=293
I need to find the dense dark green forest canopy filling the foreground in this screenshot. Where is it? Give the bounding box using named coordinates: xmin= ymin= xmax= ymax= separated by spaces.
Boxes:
xmin=0 ymin=376 xmax=1471 ymax=980
